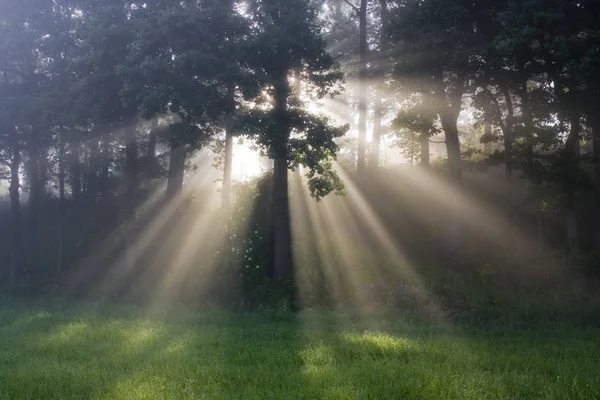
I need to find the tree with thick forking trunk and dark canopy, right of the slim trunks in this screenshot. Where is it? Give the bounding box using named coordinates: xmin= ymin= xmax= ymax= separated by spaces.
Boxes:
xmin=389 ymin=0 xmax=479 ymax=181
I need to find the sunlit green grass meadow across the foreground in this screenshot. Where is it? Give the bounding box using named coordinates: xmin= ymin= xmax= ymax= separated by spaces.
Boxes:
xmin=0 ymin=302 xmax=600 ymax=400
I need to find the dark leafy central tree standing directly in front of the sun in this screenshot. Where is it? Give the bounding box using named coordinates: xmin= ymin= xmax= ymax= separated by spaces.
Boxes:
xmin=248 ymin=0 xmax=347 ymax=278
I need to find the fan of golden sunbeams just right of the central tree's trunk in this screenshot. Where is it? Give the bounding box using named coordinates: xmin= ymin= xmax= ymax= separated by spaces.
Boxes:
xmin=290 ymin=162 xmax=427 ymax=310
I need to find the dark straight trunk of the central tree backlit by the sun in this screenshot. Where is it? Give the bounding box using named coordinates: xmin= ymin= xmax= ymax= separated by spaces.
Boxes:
xmin=272 ymin=75 xmax=291 ymax=278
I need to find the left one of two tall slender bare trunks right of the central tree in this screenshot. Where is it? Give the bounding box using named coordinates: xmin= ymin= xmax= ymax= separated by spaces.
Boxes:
xmin=356 ymin=0 xmax=368 ymax=177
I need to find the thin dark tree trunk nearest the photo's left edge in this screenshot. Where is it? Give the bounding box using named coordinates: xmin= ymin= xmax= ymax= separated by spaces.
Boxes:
xmin=8 ymin=127 xmax=21 ymax=291
